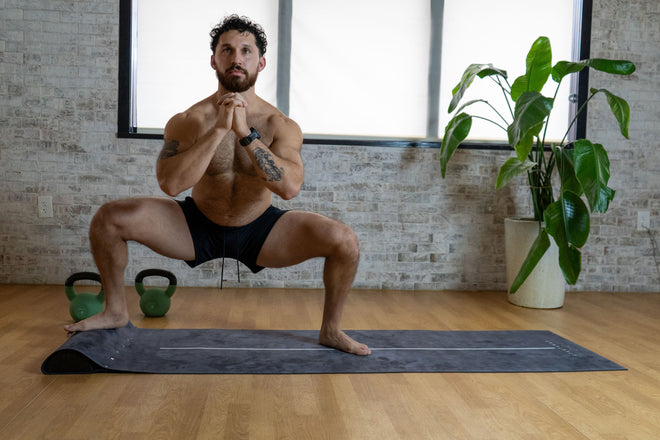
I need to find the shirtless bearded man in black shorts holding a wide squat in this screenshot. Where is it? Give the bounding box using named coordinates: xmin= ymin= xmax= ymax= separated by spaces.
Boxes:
xmin=65 ymin=15 xmax=371 ymax=355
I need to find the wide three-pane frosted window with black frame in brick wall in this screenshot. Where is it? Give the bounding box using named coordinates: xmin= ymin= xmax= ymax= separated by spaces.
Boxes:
xmin=119 ymin=0 xmax=591 ymax=145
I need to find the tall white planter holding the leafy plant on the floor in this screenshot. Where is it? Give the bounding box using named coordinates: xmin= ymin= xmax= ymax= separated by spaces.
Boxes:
xmin=504 ymin=218 xmax=566 ymax=309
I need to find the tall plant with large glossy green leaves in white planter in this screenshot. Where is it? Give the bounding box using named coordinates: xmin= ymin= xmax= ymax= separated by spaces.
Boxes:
xmin=440 ymin=37 xmax=635 ymax=306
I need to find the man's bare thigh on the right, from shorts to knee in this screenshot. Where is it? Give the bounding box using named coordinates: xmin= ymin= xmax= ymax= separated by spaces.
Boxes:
xmin=257 ymin=211 xmax=357 ymax=267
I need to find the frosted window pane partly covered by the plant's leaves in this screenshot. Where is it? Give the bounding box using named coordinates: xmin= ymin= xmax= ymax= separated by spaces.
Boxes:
xmin=440 ymin=0 xmax=573 ymax=140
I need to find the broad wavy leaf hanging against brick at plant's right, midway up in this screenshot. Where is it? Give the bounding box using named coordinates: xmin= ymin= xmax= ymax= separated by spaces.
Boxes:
xmin=575 ymin=139 xmax=614 ymax=212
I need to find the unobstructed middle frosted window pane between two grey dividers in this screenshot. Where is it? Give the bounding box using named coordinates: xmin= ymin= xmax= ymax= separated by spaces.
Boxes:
xmin=290 ymin=0 xmax=430 ymax=137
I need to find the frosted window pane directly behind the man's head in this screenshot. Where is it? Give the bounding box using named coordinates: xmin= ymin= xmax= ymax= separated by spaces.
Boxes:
xmin=133 ymin=0 xmax=278 ymax=128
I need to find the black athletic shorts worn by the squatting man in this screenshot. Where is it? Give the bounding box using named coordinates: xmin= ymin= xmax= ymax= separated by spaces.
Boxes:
xmin=177 ymin=197 xmax=287 ymax=273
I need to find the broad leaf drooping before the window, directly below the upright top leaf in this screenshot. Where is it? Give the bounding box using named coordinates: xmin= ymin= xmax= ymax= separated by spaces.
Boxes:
xmin=507 ymin=92 xmax=553 ymax=161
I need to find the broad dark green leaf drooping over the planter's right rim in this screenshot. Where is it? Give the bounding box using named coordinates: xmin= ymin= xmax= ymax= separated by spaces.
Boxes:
xmin=543 ymin=191 xmax=590 ymax=284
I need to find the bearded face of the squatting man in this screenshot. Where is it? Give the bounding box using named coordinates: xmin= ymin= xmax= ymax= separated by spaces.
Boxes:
xmin=211 ymin=31 xmax=266 ymax=93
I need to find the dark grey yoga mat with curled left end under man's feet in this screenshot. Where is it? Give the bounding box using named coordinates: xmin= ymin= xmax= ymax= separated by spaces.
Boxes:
xmin=41 ymin=323 xmax=625 ymax=374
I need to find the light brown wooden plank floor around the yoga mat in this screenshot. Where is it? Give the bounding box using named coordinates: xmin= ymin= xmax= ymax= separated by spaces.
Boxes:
xmin=0 ymin=285 xmax=660 ymax=440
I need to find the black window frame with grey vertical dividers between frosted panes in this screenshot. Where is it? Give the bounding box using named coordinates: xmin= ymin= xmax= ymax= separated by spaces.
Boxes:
xmin=117 ymin=0 xmax=593 ymax=150
